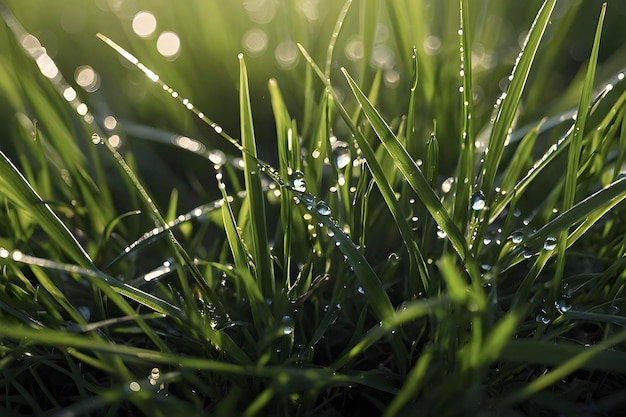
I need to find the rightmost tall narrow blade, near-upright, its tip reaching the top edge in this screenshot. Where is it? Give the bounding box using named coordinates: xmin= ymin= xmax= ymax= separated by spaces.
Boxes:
xmin=551 ymin=3 xmax=606 ymax=299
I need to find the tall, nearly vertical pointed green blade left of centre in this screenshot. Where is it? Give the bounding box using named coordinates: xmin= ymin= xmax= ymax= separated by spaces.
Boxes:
xmin=239 ymin=54 xmax=275 ymax=297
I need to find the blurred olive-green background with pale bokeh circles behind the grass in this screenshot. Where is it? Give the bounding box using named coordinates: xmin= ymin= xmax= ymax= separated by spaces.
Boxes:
xmin=0 ymin=0 xmax=626 ymax=208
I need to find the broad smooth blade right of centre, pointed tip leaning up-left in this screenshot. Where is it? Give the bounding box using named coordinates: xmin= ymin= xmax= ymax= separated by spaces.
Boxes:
xmin=343 ymin=69 xmax=480 ymax=282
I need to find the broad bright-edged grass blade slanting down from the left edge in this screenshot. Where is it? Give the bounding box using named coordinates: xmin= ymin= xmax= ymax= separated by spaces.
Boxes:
xmin=0 ymin=151 xmax=94 ymax=267
